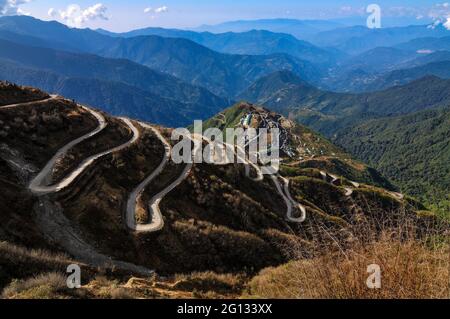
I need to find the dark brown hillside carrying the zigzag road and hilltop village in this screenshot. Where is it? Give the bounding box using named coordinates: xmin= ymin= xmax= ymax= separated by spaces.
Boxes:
xmin=0 ymin=87 xmax=431 ymax=298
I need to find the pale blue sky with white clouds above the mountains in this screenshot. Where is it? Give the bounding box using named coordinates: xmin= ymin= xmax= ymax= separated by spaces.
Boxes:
xmin=6 ymin=0 xmax=450 ymax=31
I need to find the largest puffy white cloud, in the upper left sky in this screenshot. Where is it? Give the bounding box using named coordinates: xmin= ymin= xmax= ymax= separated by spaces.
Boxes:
xmin=58 ymin=3 xmax=109 ymax=28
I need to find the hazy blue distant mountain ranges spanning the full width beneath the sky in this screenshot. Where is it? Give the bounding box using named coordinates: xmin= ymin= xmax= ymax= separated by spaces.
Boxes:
xmin=0 ymin=16 xmax=449 ymax=99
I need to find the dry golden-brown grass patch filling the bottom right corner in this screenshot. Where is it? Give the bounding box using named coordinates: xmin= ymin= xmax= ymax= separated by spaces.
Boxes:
xmin=247 ymin=233 xmax=450 ymax=299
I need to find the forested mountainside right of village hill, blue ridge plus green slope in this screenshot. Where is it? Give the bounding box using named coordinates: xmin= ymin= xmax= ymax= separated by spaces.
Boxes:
xmin=246 ymin=73 xmax=450 ymax=209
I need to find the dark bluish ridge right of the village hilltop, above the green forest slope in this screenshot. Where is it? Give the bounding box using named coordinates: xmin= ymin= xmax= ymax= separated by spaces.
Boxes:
xmin=240 ymin=72 xmax=450 ymax=136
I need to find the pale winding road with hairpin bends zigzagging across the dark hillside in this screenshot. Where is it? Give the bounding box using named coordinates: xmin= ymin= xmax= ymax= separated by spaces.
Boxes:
xmin=0 ymin=95 xmax=404 ymax=232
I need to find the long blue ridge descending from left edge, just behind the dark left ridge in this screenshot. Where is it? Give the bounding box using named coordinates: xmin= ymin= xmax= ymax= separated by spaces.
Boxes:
xmin=0 ymin=17 xmax=320 ymax=98
